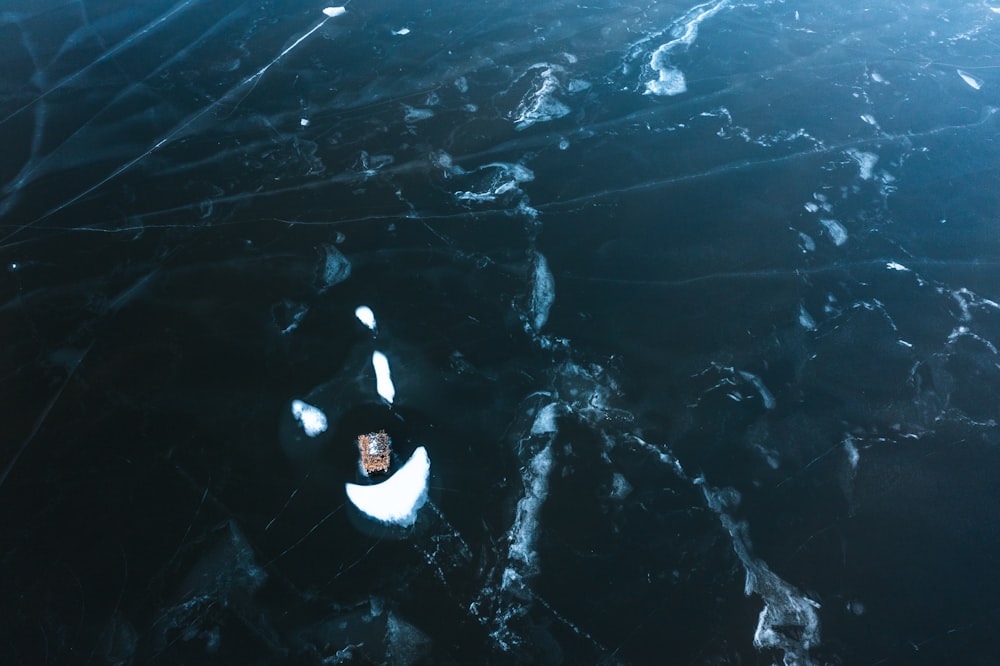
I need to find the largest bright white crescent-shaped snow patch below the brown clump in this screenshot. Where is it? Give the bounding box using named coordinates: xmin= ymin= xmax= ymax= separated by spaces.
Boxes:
xmin=344 ymin=446 xmax=431 ymax=527
